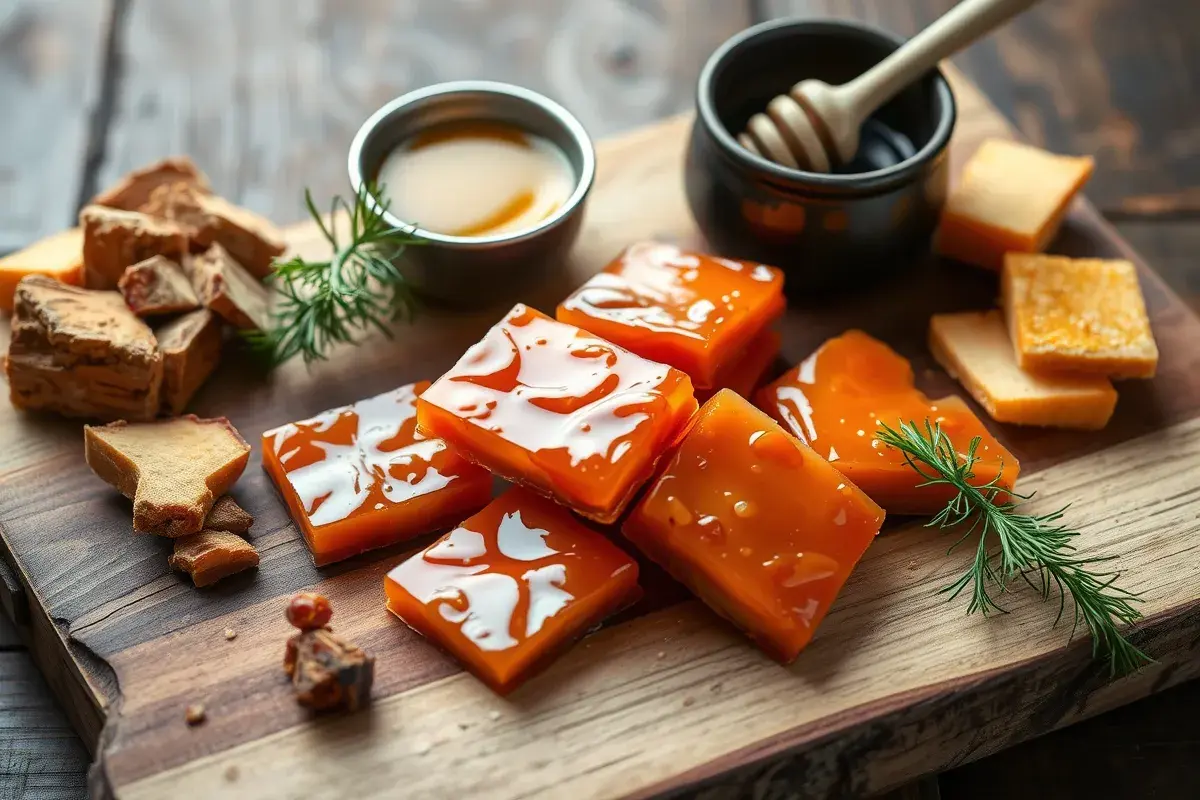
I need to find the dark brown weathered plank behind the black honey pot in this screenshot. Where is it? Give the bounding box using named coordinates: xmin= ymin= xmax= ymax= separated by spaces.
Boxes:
xmin=763 ymin=0 xmax=1200 ymax=216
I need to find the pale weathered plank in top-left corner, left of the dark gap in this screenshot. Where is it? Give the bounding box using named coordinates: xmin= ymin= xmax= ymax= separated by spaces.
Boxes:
xmin=0 ymin=0 xmax=112 ymax=253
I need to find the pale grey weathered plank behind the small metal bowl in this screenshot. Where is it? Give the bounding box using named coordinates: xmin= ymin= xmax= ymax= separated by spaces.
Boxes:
xmin=101 ymin=0 xmax=750 ymax=222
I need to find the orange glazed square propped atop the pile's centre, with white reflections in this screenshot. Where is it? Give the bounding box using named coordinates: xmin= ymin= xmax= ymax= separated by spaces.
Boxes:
xmin=418 ymin=305 xmax=696 ymax=523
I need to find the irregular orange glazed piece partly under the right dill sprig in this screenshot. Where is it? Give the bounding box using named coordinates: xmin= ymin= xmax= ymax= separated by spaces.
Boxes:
xmin=756 ymin=331 xmax=1020 ymax=515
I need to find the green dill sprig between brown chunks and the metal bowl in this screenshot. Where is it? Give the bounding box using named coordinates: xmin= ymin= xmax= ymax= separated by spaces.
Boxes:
xmin=247 ymin=185 xmax=424 ymax=363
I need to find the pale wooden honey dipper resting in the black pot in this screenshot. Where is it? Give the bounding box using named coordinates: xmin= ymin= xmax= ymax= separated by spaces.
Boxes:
xmin=738 ymin=0 xmax=1037 ymax=173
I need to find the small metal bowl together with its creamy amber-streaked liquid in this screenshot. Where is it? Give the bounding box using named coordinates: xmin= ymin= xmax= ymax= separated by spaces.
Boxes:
xmin=348 ymin=80 xmax=595 ymax=307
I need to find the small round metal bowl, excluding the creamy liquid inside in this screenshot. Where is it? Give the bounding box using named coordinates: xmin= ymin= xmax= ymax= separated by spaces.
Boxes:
xmin=348 ymin=80 xmax=595 ymax=307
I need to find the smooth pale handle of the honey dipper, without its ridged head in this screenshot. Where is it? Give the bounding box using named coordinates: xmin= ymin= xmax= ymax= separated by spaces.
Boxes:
xmin=839 ymin=0 xmax=1038 ymax=125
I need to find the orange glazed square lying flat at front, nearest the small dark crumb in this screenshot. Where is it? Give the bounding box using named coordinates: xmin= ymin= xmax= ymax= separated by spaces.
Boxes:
xmin=384 ymin=487 xmax=638 ymax=693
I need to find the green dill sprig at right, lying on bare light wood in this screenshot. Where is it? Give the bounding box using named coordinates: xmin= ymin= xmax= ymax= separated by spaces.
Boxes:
xmin=876 ymin=420 xmax=1151 ymax=675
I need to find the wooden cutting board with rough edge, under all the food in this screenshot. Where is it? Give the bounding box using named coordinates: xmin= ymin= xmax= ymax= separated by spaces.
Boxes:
xmin=0 ymin=68 xmax=1200 ymax=798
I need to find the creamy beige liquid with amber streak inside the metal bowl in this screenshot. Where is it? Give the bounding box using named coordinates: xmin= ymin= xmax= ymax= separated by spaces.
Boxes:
xmin=377 ymin=122 xmax=576 ymax=236
